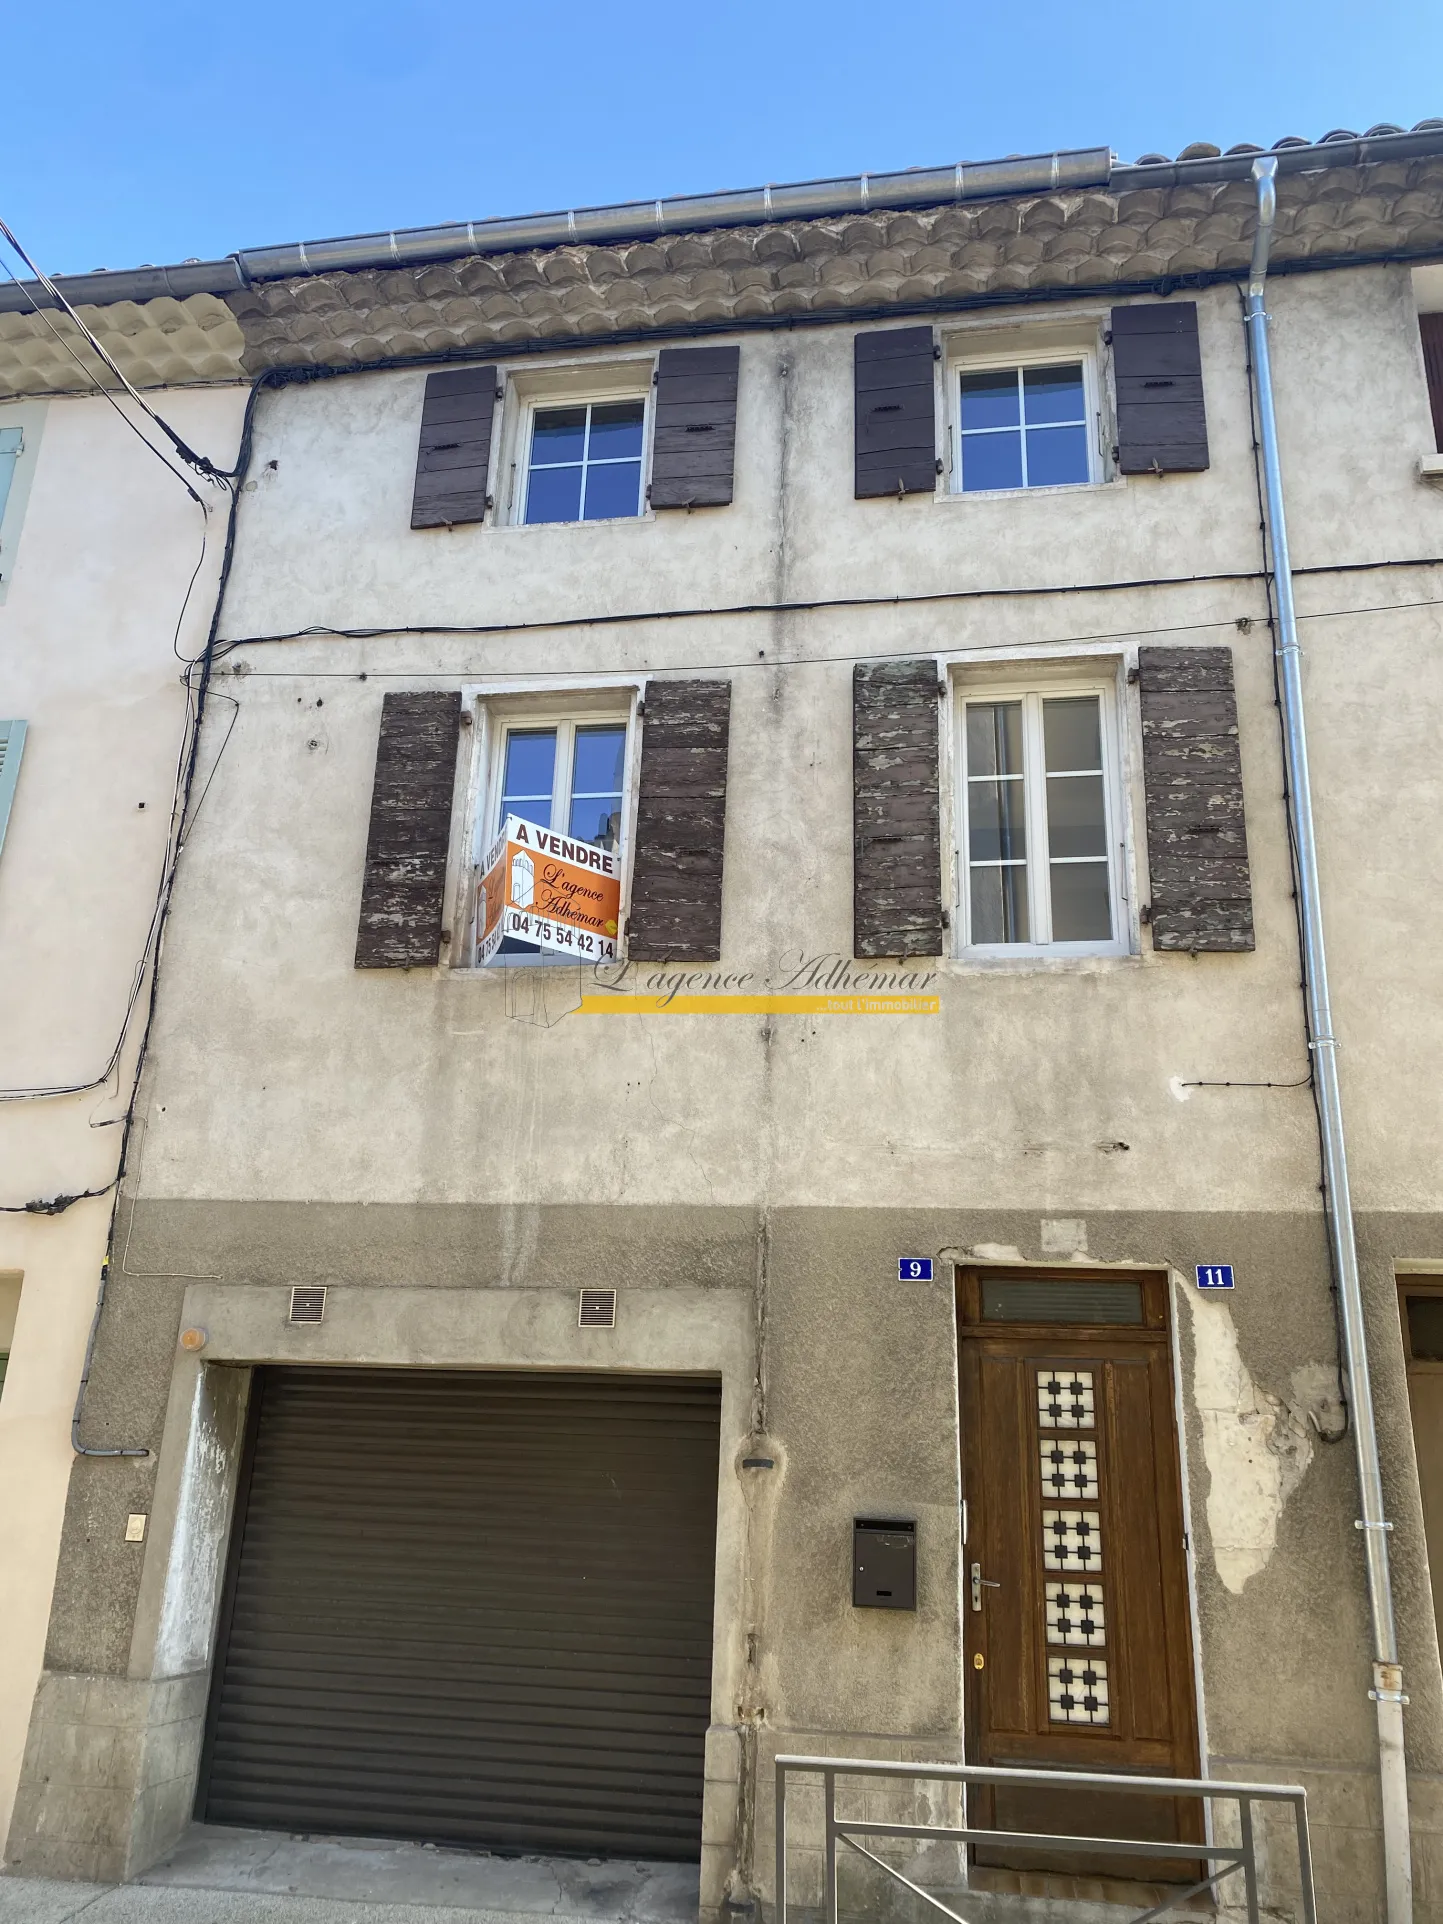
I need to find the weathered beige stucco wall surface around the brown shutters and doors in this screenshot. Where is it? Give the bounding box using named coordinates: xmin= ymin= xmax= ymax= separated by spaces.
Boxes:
xmin=0 ymin=127 xmax=1443 ymax=1924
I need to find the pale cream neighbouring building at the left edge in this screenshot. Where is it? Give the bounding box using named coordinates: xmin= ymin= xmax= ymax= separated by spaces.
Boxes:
xmin=0 ymin=300 xmax=246 ymax=1847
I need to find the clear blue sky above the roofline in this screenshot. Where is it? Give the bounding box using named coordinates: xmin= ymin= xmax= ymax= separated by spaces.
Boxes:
xmin=0 ymin=0 xmax=1443 ymax=273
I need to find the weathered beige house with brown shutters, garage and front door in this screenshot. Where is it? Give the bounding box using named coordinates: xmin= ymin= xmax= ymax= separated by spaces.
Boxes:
xmin=0 ymin=123 xmax=1443 ymax=1924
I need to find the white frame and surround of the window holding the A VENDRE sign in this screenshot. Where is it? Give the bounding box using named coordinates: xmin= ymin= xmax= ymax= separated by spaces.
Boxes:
xmin=448 ymin=684 xmax=643 ymax=974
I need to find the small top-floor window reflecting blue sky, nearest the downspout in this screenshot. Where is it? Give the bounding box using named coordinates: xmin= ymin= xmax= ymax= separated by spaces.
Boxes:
xmin=954 ymin=360 xmax=1097 ymax=494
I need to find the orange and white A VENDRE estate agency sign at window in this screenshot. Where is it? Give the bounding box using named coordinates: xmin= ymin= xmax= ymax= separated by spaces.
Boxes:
xmin=475 ymin=816 xmax=621 ymax=964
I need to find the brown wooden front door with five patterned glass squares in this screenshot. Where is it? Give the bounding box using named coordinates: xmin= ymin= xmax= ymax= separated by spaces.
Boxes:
xmin=958 ymin=1270 xmax=1201 ymax=1882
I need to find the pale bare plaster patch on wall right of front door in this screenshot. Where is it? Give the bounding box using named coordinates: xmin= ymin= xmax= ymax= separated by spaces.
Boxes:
xmin=1187 ymin=1289 xmax=1335 ymax=1597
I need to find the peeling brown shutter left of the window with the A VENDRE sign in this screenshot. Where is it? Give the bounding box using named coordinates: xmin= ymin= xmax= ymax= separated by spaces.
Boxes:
xmin=356 ymin=693 xmax=462 ymax=968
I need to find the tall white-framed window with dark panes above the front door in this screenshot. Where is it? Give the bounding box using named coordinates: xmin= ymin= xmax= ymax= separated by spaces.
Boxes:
xmin=960 ymin=685 xmax=1127 ymax=954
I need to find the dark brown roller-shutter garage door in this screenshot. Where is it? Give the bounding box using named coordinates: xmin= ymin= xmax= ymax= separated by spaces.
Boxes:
xmin=198 ymin=1370 xmax=720 ymax=1859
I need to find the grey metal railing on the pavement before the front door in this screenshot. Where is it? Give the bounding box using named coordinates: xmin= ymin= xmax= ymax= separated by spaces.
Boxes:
xmin=775 ymin=1757 xmax=1318 ymax=1924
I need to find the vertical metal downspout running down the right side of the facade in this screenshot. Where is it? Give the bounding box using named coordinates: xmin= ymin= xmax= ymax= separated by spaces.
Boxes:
xmin=1247 ymin=154 xmax=1412 ymax=1924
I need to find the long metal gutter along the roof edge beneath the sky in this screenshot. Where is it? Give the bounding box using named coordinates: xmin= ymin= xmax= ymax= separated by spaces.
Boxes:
xmin=0 ymin=121 xmax=1443 ymax=314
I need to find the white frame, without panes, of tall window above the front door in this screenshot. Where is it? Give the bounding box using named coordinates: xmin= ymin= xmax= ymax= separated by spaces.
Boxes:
xmin=952 ymin=677 xmax=1133 ymax=962
